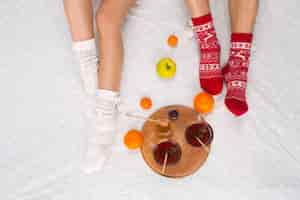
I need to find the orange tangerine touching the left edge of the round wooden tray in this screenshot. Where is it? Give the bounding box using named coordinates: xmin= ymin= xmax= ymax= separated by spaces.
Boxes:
xmin=124 ymin=130 xmax=143 ymax=149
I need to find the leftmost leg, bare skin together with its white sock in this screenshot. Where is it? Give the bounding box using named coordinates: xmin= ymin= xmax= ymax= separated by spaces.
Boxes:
xmin=64 ymin=0 xmax=98 ymax=95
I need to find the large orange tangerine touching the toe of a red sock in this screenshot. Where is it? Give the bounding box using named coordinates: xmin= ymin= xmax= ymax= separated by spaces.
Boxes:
xmin=194 ymin=92 xmax=215 ymax=114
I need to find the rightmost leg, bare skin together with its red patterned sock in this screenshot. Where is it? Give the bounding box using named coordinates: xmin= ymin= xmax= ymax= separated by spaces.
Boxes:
xmin=223 ymin=0 xmax=258 ymax=116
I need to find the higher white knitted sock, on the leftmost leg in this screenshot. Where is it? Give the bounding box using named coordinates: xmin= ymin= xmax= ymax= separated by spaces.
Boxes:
xmin=73 ymin=38 xmax=98 ymax=95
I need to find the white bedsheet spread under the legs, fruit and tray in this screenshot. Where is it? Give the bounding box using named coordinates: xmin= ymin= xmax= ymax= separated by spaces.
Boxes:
xmin=0 ymin=0 xmax=300 ymax=200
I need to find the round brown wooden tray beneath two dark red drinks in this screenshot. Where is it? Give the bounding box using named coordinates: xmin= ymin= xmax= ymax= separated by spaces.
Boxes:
xmin=141 ymin=105 xmax=213 ymax=178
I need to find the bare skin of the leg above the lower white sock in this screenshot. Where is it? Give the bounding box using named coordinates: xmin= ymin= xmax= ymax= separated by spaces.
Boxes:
xmin=96 ymin=0 xmax=134 ymax=91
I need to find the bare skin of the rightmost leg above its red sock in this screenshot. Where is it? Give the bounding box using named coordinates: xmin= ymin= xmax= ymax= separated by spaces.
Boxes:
xmin=229 ymin=0 xmax=258 ymax=33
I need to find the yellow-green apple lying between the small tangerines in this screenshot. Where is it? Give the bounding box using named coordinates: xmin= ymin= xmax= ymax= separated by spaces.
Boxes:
xmin=156 ymin=58 xmax=176 ymax=79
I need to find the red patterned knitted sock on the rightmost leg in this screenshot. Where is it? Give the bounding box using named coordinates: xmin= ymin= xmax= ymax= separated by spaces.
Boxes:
xmin=223 ymin=33 xmax=253 ymax=116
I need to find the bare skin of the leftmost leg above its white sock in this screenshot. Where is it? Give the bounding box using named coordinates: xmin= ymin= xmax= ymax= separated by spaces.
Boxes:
xmin=64 ymin=0 xmax=94 ymax=41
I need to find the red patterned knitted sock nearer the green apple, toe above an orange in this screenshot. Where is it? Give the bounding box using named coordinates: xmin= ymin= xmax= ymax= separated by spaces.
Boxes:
xmin=192 ymin=14 xmax=223 ymax=95
